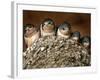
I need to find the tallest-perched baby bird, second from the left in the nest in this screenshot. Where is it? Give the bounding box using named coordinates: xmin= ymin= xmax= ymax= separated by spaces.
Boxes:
xmin=40 ymin=18 xmax=55 ymax=37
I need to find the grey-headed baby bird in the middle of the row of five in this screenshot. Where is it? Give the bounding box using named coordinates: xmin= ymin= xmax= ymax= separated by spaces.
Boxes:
xmin=57 ymin=22 xmax=71 ymax=39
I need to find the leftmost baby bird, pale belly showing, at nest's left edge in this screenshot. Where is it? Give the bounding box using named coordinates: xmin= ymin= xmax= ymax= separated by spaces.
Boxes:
xmin=24 ymin=24 xmax=40 ymax=48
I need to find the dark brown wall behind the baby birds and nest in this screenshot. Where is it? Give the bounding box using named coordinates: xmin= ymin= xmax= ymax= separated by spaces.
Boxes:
xmin=23 ymin=10 xmax=91 ymax=51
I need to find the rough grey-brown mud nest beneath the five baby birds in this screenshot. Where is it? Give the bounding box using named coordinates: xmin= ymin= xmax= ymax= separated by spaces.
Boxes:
xmin=23 ymin=36 xmax=91 ymax=69
